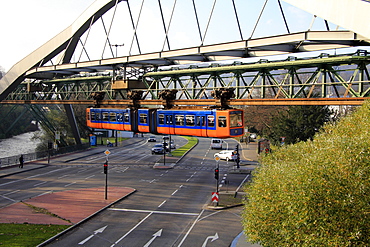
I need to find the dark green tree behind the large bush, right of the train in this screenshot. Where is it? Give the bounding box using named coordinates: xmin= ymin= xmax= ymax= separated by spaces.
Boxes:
xmin=268 ymin=106 xmax=332 ymax=144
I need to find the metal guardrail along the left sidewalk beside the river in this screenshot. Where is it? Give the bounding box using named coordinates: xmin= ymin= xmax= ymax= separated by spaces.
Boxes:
xmin=0 ymin=143 xmax=90 ymax=168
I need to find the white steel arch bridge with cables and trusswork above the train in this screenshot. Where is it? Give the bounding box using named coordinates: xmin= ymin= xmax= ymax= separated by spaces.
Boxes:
xmin=0 ymin=0 xmax=370 ymax=104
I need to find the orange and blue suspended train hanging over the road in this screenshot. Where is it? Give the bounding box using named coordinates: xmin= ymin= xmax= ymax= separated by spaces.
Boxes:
xmin=86 ymin=108 xmax=244 ymax=138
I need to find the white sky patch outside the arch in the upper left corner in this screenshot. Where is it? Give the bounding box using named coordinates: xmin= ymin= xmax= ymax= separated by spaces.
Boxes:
xmin=0 ymin=0 xmax=94 ymax=71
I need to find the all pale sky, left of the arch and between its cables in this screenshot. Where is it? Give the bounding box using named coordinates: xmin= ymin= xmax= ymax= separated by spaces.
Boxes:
xmin=0 ymin=0 xmax=364 ymax=71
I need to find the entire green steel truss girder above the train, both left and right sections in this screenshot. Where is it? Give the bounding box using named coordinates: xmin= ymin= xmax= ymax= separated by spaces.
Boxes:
xmin=2 ymin=53 xmax=370 ymax=101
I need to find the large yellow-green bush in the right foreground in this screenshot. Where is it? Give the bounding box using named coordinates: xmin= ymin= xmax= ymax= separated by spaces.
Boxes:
xmin=243 ymin=101 xmax=370 ymax=247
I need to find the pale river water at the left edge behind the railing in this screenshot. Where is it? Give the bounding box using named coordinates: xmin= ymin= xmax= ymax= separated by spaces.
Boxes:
xmin=0 ymin=131 xmax=40 ymax=158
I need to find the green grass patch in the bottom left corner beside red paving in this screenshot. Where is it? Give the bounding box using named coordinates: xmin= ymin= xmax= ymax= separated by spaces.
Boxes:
xmin=0 ymin=224 xmax=70 ymax=247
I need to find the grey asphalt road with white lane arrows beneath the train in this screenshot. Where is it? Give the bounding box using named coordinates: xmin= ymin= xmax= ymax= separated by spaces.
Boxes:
xmin=0 ymin=137 xmax=250 ymax=246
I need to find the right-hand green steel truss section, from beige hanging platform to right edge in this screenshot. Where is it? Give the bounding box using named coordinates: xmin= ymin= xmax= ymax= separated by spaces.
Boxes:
xmin=144 ymin=54 xmax=370 ymax=99
